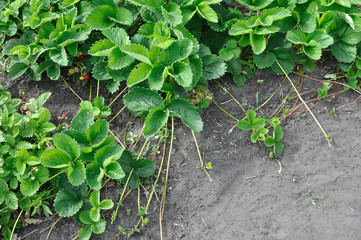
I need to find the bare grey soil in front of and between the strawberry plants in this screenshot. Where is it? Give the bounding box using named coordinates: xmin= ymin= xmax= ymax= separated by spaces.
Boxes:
xmin=1 ymin=61 xmax=361 ymax=240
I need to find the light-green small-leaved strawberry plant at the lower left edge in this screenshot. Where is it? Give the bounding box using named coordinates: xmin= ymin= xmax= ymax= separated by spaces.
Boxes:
xmin=0 ymin=86 xmax=55 ymax=239
